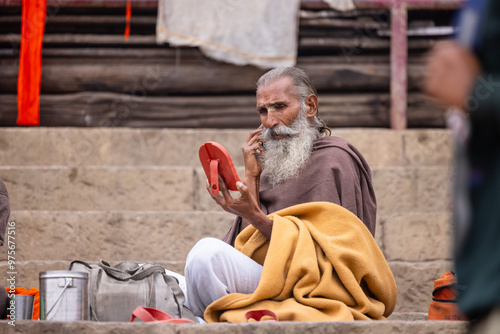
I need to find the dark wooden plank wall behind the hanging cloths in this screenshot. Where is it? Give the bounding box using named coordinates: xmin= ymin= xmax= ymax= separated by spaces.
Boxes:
xmin=0 ymin=1 xmax=453 ymax=128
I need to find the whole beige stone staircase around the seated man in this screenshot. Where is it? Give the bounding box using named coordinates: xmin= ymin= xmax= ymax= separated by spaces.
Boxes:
xmin=0 ymin=127 xmax=467 ymax=334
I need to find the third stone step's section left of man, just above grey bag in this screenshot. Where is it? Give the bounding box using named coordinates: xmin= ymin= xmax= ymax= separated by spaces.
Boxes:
xmin=0 ymin=211 xmax=234 ymax=261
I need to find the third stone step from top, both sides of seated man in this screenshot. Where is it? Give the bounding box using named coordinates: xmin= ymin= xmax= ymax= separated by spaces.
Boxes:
xmin=0 ymin=211 xmax=452 ymax=262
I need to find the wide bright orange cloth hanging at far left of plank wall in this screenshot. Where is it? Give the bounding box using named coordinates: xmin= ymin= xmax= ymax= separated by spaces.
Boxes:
xmin=17 ymin=0 xmax=47 ymax=125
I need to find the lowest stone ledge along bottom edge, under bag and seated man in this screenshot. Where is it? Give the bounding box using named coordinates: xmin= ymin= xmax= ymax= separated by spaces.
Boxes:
xmin=0 ymin=320 xmax=468 ymax=334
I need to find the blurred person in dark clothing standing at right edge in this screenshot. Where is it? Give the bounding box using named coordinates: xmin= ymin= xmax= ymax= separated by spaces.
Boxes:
xmin=425 ymin=0 xmax=500 ymax=333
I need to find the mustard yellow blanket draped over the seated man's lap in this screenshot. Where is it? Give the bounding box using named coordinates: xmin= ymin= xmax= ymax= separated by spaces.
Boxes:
xmin=205 ymin=202 xmax=397 ymax=323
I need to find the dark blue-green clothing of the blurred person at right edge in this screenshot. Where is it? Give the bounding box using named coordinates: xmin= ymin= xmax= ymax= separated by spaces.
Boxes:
xmin=456 ymin=0 xmax=500 ymax=318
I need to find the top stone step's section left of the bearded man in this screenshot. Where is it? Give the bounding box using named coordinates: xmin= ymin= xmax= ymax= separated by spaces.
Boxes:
xmin=0 ymin=127 xmax=249 ymax=168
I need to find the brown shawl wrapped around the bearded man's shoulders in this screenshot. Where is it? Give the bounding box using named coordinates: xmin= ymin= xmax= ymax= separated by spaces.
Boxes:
xmin=223 ymin=137 xmax=377 ymax=246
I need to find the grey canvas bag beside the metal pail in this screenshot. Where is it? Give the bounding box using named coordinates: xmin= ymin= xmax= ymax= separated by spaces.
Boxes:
xmin=69 ymin=260 xmax=198 ymax=322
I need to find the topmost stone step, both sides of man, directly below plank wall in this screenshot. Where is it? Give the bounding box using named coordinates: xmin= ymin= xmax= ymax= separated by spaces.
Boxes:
xmin=0 ymin=127 xmax=452 ymax=168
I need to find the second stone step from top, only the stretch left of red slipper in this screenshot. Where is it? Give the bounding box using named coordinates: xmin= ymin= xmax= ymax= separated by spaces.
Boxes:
xmin=0 ymin=166 xmax=194 ymax=210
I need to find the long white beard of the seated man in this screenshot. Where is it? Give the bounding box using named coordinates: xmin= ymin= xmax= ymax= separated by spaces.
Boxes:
xmin=262 ymin=109 xmax=319 ymax=188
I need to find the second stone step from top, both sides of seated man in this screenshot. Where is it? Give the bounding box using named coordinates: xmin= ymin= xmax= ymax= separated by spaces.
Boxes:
xmin=0 ymin=166 xmax=452 ymax=216
